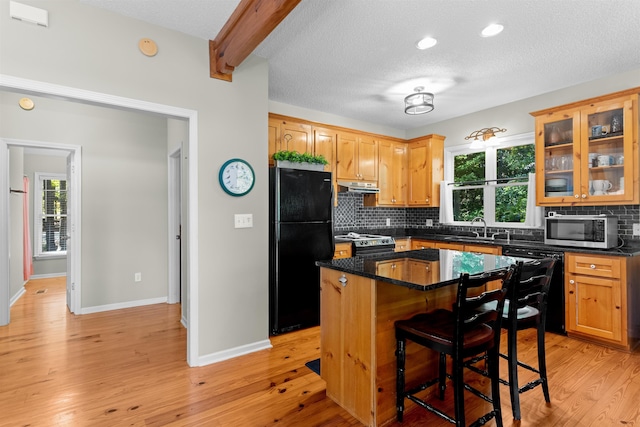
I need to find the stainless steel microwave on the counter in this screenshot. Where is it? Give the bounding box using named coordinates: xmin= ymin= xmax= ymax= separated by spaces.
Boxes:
xmin=544 ymin=215 xmax=618 ymax=249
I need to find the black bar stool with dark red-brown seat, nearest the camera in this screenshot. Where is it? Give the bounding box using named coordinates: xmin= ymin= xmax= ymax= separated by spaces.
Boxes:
xmin=395 ymin=266 xmax=518 ymax=427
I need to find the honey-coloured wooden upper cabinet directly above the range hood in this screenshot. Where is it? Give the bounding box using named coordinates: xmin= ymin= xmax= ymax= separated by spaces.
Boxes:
xmin=336 ymin=131 xmax=378 ymax=181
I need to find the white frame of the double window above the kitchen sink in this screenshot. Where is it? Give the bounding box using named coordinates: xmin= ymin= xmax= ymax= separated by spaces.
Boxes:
xmin=444 ymin=132 xmax=535 ymax=228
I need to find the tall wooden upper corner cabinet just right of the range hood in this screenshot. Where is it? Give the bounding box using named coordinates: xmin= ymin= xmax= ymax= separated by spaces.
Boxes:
xmin=364 ymin=139 xmax=409 ymax=206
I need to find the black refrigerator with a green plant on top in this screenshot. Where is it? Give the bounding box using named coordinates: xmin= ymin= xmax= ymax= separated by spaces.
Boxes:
xmin=269 ymin=168 xmax=334 ymax=335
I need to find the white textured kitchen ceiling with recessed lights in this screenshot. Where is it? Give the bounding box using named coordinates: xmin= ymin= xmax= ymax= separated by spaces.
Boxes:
xmin=81 ymin=0 xmax=640 ymax=129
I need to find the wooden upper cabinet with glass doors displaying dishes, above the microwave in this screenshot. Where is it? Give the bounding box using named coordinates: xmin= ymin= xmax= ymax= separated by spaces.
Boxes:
xmin=531 ymin=88 xmax=640 ymax=206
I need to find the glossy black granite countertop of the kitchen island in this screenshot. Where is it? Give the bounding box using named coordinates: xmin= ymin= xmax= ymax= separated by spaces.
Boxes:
xmin=316 ymin=249 xmax=528 ymax=291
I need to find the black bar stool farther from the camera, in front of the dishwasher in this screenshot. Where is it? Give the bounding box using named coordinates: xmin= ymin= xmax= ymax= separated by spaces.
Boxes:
xmin=467 ymin=258 xmax=557 ymax=420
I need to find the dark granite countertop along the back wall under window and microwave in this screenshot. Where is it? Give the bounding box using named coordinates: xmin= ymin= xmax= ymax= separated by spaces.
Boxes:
xmin=336 ymin=228 xmax=640 ymax=257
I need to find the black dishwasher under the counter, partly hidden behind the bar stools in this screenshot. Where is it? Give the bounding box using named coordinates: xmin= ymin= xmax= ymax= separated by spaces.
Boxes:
xmin=502 ymin=246 xmax=567 ymax=335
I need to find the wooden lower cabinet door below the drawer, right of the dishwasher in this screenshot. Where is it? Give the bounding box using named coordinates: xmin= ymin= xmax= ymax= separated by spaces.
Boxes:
xmin=567 ymin=274 xmax=622 ymax=341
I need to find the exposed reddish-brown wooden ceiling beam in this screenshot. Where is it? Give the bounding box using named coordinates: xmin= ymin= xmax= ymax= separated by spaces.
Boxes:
xmin=209 ymin=0 xmax=301 ymax=82
